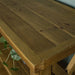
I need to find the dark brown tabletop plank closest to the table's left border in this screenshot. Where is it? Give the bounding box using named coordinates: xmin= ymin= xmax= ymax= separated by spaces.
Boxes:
xmin=0 ymin=5 xmax=55 ymax=53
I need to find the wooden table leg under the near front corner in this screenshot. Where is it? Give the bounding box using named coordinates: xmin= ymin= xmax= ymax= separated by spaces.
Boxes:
xmin=30 ymin=66 xmax=51 ymax=75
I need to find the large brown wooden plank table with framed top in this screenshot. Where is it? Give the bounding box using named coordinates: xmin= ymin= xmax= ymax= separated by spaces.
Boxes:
xmin=0 ymin=0 xmax=75 ymax=75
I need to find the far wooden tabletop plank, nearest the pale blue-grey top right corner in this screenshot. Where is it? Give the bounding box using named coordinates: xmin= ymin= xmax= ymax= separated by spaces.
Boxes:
xmin=2 ymin=0 xmax=75 ymax=37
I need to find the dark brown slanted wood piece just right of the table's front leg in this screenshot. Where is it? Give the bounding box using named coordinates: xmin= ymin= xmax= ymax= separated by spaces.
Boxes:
xmin=52 ymin=64 xmax=68 ymax=75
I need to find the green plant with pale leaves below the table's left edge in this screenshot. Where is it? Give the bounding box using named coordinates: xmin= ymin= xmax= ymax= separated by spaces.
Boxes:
xmin=0 ymin=37 xmax=21 ymax=71
